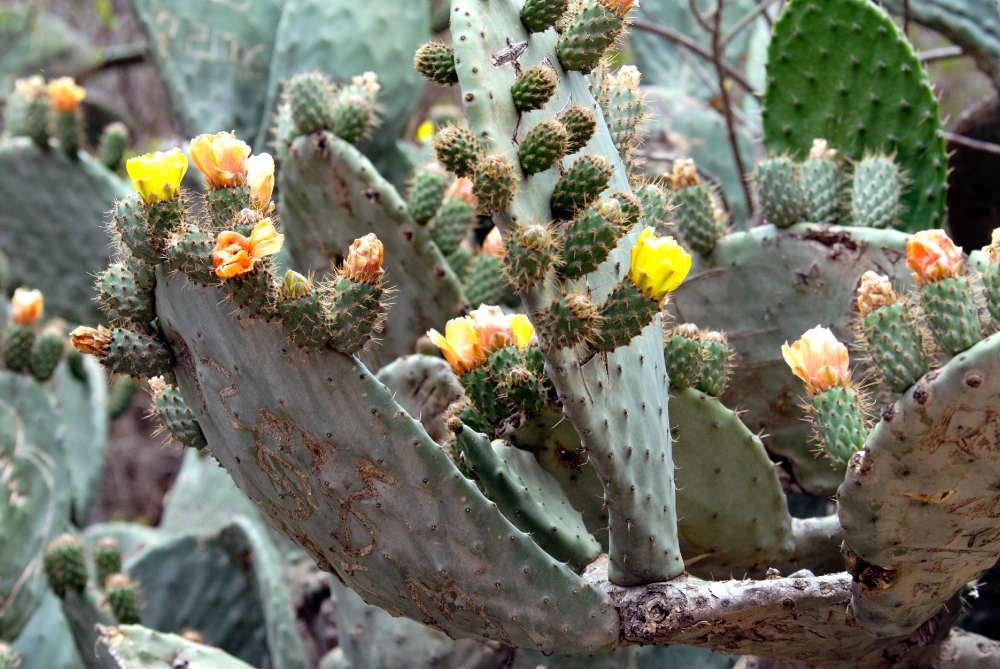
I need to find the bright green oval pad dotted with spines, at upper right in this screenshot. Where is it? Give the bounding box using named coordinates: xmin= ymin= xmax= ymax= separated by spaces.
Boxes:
xmin=763 ymin=0 xmax=948 ymax=232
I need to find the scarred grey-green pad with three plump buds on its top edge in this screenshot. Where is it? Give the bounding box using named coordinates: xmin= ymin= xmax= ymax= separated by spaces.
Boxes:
xmin=667 ymin=224 xmax=913 ymax=495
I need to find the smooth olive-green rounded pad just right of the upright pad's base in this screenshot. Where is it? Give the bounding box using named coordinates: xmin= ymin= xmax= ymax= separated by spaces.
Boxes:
xmin=670 ymin=388 xmax=794 ymax=578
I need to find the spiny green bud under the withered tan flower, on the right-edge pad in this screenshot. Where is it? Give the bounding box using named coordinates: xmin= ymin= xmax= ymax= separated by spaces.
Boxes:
xmin=860 ymin=302 xmax=930 ymax=393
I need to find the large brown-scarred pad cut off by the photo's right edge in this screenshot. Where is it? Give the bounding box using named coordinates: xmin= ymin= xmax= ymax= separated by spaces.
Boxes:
xmin=838 ymin=335 xmax=1000 ymax=636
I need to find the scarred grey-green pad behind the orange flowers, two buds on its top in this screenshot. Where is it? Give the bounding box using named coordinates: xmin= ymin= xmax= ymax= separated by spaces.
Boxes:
xmin=279 ymin=133 xmax=462 ymax=369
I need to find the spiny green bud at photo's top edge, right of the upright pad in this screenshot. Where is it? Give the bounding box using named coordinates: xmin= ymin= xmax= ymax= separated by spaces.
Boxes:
xmin=556 ymin=0 xmax=631 ymax=74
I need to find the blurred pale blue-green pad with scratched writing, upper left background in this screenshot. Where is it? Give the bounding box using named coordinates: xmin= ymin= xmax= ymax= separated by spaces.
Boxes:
xmin=132 ymin=0 xmax=284 ymax=145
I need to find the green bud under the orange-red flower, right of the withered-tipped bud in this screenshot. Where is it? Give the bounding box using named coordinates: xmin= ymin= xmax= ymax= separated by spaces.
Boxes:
xmin=920 ymin=276 xmax=982 ymax=355
